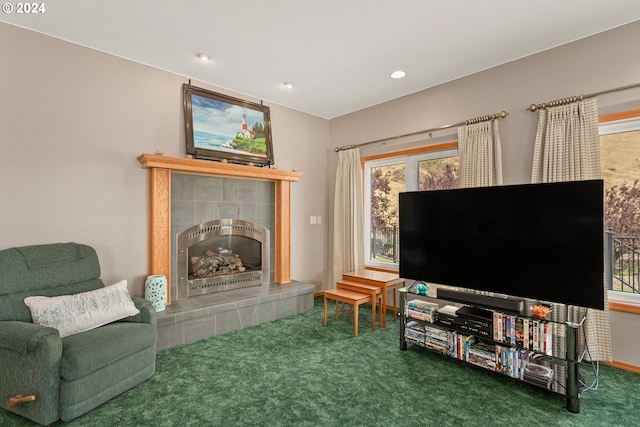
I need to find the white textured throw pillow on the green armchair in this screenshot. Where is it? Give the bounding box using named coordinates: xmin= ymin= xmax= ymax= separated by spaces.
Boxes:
xmin=24 ymin=280 xmax=140 ymax=337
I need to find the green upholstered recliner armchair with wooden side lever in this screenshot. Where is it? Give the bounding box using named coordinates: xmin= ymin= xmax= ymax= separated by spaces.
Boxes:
xmin=0 ymin=243 xmax=157 ymax=425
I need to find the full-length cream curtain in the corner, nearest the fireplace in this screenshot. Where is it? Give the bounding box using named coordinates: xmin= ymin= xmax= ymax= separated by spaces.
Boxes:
xmin=333 ymin=148 xmax=364 ymax=285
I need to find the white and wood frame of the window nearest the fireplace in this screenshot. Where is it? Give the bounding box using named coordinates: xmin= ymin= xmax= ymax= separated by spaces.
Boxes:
xmin=360 ymin=141 xmax=459 ymax=272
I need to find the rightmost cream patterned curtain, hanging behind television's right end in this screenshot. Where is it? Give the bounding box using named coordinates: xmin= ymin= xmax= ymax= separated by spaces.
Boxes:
xmin=531 ymin=98 xmax=612 ymax=361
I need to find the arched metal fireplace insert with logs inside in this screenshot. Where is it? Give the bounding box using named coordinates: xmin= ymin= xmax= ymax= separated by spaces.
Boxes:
xmin=176 ymin=219 xmax=270 ymax=299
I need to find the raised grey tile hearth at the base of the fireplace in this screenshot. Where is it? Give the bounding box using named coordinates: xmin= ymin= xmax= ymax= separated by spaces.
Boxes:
xmin=156 ymin=280 xmax=315 ymax=350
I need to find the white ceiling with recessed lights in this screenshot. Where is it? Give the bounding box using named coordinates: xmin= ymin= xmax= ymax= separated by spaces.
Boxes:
xmin=0 ymin=0 xmax=640 ymax=119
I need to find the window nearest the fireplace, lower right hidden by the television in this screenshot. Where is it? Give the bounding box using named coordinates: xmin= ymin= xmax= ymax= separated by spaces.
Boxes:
xmin=362 ymin=142 xmax=458 ymax=269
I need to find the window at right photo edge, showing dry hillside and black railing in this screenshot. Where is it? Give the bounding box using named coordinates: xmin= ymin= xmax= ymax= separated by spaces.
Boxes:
xmin=599 ymin=112 xmax=640 ymax=303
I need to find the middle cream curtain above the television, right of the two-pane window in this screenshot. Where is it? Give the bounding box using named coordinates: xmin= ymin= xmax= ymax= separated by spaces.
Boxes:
xmin=458 ymin=120 xmax=502 ymax=187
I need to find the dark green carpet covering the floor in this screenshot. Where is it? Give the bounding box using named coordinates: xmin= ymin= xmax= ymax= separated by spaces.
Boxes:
xmin=0 ymin=298 xmax=640 ymax=427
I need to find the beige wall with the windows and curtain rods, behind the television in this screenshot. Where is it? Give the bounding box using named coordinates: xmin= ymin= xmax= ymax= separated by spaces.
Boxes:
xmin=330 ymin=21 xmax=640 ymax=366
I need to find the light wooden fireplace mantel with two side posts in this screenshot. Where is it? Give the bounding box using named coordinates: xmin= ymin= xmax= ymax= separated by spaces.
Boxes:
xmin=138 ymin=154 xmax=302 ymax=304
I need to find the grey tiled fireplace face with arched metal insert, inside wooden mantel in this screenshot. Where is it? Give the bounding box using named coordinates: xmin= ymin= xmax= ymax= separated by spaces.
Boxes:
xmin=171 ymin=172 xmax=277 ymax=302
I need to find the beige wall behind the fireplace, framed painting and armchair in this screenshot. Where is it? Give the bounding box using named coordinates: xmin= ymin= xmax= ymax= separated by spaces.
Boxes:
xmin=0 ymin=23 xmax=329 ymax=295
